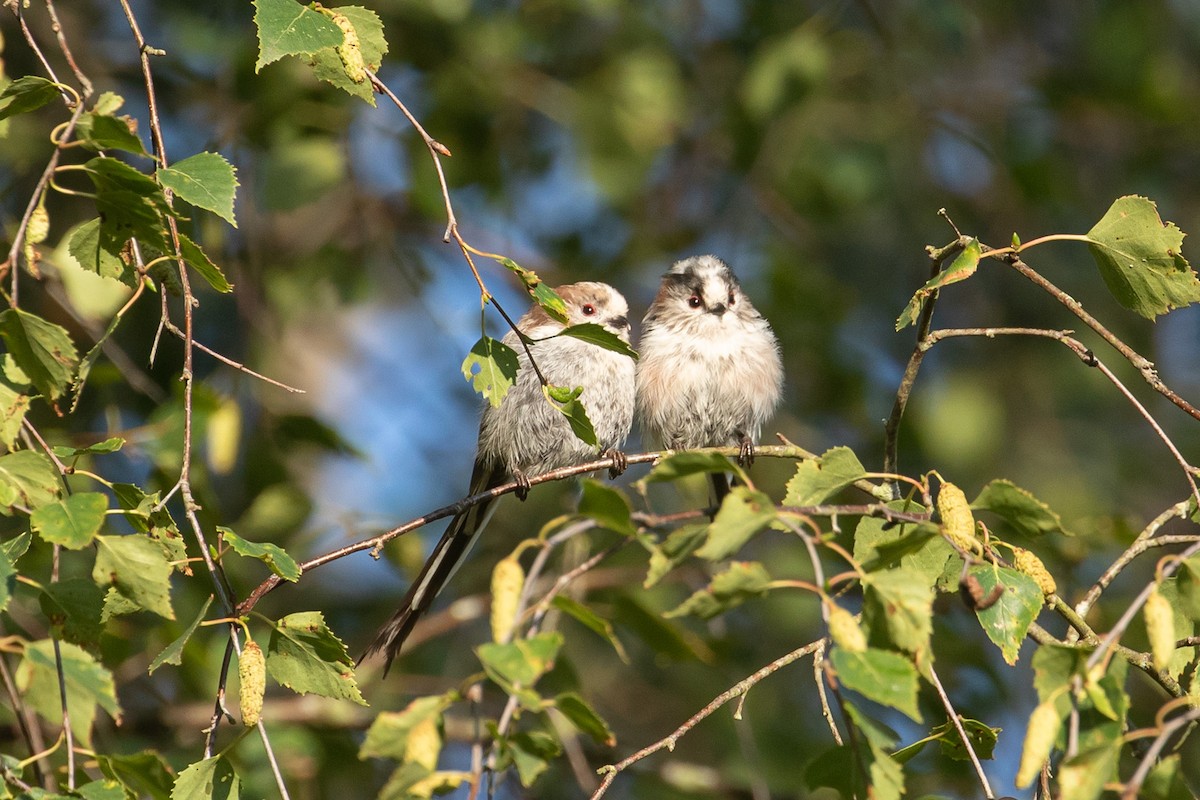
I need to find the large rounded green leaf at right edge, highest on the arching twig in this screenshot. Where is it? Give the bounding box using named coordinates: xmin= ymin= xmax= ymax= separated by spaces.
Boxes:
xmin=1087 ymin=196 xmax=1200 ymax=319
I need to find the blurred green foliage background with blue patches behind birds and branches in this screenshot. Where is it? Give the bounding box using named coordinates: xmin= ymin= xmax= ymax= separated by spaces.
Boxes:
xmin=0 ymin=0 xmax=1200 ymax=798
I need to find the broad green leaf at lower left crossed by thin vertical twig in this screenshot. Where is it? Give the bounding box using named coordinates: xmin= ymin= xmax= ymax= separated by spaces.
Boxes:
xmin=17 ymin=639 xmax=121 ymax=747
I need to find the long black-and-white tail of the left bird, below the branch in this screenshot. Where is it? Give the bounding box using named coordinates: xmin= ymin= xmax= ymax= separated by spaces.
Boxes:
xmin=359 ymin=464 xmax=504 ymax=676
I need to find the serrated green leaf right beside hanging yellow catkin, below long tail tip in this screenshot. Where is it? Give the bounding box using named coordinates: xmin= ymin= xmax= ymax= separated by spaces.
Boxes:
xmin=266 ymin=612 xmax=367 ymax=705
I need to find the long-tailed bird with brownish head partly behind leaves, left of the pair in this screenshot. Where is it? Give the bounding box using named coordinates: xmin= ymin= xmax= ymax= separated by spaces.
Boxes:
xmin=359 ymin=281 xmax=635 ymax=676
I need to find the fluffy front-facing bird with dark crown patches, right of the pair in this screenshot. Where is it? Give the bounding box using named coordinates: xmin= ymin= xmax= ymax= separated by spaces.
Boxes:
xmin=636 ymin=255 xmax=784 ymax=496
